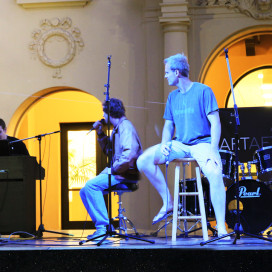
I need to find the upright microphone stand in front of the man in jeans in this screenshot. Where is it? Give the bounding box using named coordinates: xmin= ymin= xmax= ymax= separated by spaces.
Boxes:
xmin=79 ymin=56 xmax=155 ymax=246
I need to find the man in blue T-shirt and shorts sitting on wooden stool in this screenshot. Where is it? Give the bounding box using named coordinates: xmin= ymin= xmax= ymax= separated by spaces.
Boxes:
xmin=137 ymin=54 xmax=229 ymax=239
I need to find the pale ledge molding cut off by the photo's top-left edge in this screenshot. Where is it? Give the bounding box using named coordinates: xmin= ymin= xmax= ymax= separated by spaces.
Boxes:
xmin=16 ymin=0 xmax=91 ymax=8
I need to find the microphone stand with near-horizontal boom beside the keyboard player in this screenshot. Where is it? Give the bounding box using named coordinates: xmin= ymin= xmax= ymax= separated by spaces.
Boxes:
xmin=10 ymin=130 xmax=74 ymax=238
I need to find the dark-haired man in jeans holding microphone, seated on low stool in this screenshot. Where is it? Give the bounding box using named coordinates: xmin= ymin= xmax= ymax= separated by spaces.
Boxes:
xmin=80 ymin=98 xmax=142 ymax=239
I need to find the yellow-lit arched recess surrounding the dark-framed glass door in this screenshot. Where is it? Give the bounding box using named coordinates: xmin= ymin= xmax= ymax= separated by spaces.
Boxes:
xmin=8 ymin=87 xmax=107 ymax=230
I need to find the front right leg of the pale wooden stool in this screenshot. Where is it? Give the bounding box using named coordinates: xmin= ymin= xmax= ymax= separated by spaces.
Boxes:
xmin=195 ymin=167 xmax=208 ymax=241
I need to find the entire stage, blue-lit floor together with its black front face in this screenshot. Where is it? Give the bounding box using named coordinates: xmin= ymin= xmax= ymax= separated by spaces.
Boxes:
xmin=0 ymin=230 xmax=272 ymax=272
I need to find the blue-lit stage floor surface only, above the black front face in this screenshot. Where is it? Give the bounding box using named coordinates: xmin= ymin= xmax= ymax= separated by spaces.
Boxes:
xmin=0 ymin=230 xmax=272 ymax=251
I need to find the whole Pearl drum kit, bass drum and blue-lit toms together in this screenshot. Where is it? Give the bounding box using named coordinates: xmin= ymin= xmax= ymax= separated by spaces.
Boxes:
xmin=219 ymin=146 xmax=272 ymax=234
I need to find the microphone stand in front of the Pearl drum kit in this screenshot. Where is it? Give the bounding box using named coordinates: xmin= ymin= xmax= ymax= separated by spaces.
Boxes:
xmin=200 ymin=49 xmax=272 ymax=246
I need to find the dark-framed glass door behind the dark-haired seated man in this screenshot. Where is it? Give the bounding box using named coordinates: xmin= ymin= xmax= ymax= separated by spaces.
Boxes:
xmin=60 ymin=123 xmax=118 ymax=229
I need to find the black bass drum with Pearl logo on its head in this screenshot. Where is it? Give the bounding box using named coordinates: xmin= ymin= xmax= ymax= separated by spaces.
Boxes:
xmin=226 ymin=180 xmax=272 ymax=234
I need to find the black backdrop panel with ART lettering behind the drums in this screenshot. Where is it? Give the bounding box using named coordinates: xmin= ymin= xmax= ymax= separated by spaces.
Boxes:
xmin=219 ymin=107 xmax=272 ymax=162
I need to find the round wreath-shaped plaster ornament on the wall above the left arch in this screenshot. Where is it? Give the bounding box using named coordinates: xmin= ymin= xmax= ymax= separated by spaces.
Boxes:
xmin=29 ymin=17 xmax=84 ymax=78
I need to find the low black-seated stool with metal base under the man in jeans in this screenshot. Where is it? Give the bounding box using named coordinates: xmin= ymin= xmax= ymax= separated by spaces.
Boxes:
xmin=104 ymin=182 xmax=139 ymax=235
